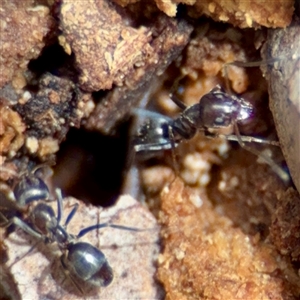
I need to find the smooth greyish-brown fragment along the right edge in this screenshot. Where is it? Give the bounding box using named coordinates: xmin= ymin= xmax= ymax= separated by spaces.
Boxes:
xmin=262 ymin=19 xmax=300 ymax=192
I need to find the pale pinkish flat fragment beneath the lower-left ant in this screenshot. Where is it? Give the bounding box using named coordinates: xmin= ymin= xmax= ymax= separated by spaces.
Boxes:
xmin=0 ymin=196 xmax=162 ymax=300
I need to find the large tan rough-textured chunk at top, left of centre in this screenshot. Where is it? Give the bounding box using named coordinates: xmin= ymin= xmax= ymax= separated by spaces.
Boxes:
xmin=60 ymin=0 xmax=191 ymax=91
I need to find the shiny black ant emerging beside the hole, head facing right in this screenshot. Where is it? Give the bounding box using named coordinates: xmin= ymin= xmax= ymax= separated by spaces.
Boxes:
xmin=133 ymin=85 xmax=289 ymax=183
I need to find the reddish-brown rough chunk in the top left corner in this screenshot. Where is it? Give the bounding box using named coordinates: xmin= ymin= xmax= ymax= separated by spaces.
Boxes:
xmin=0 ymin=0 xmax=54 ymax=89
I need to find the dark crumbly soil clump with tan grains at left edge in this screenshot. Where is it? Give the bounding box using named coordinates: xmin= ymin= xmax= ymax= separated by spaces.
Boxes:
xmin=0 ymin=73 xmax=94 ymax=160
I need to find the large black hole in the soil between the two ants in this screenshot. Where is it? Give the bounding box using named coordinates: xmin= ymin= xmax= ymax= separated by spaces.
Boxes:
xmin=53 ymin=125 xmax=128 ymax=206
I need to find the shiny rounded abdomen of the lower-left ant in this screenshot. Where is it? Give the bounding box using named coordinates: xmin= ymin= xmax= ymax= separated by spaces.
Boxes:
xmin=61 ymin=242 xmax=114 ymax=287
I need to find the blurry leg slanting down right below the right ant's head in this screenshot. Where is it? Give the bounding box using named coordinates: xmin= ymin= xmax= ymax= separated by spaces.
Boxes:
xmin=234 ymin=123 xmax=290 ymax=184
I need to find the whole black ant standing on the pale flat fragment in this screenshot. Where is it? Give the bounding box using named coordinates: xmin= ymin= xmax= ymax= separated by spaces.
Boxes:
xmin=0 ymin=164 xmax=147 ymax=293
